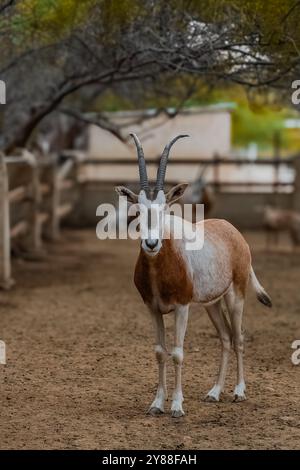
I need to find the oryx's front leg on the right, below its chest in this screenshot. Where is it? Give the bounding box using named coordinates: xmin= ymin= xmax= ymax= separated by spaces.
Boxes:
xmin=171 ymin=305 xmax=189 ymax=418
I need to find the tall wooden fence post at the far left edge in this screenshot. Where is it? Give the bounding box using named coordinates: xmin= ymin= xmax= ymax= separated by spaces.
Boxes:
xmin=0 ymin=152 xmax=14 ymax=289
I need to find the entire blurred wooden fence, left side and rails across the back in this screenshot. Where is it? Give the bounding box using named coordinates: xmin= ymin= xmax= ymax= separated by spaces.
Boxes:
xmin=0 ymin=149 xmax=300 ymax=289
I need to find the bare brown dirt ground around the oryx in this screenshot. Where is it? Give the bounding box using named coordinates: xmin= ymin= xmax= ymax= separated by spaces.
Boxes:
xmin=0 ymin=231 xmax=300 ymax=449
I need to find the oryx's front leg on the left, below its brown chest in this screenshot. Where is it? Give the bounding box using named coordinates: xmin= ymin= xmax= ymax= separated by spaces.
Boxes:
xmin=149 ymin=311 xmax=168 ymax=415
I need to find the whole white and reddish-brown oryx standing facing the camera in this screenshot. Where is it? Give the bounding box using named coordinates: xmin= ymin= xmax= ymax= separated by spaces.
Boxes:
xmin=116 ymin=134 xmax=272 ymax=418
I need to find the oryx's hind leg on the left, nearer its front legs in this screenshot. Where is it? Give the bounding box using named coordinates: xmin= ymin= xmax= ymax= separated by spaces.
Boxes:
xmin=206 ymin=300 xmax=231 ymax=401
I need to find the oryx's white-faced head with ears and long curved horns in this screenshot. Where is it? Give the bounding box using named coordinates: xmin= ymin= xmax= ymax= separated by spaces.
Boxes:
xmin=115 ymin=134 xmax=188 ymax=256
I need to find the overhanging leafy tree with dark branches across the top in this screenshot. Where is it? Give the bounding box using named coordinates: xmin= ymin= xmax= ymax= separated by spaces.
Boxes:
xmin=0 ymin=0 xmax=300 ymax=151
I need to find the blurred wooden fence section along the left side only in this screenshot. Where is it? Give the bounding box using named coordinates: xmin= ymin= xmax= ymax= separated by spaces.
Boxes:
xmin=0 ymin=150 xmax=79 ymax=289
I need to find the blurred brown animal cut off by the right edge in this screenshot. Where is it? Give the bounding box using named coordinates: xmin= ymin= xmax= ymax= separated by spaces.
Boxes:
xmin=263 ymin=205 xmax=300 ymax=247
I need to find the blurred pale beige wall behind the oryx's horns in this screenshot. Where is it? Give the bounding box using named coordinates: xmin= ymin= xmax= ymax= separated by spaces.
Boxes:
xmin=86 ymin=108 xmax=231 ymax=181
